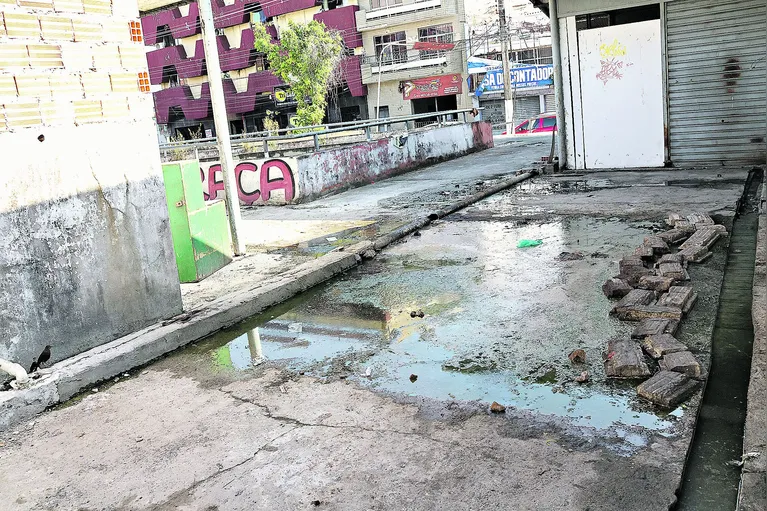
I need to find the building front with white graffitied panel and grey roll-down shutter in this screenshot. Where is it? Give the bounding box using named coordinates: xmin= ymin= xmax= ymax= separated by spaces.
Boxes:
xmin=541 ymin=0 xmax=767 ymax=169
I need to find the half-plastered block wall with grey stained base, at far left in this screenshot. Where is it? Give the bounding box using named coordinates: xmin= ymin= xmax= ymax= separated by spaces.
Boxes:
xmin=0 ymin=0 xmax=181 ymax=367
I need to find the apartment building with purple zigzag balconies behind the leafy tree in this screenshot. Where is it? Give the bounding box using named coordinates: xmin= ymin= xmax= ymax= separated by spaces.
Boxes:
xmin=140 ymin=0 xmax=367 ymax=140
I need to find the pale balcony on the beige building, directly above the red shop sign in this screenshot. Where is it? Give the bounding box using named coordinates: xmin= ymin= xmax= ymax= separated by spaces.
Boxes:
xmin=362 ymin=50 xmax=466 ymax=85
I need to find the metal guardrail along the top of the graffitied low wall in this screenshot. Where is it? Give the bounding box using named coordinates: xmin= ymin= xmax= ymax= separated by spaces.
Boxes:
xmin=160 ymin=108 xmax=484 ymax=155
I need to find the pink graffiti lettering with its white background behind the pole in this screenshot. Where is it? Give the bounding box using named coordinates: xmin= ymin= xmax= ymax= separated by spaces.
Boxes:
xmin=200 ymin=159 xmax=298 ymax=206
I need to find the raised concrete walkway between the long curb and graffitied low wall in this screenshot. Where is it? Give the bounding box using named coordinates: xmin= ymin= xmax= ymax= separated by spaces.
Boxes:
xmin=181 ymin=137 xmax=549 ymax=311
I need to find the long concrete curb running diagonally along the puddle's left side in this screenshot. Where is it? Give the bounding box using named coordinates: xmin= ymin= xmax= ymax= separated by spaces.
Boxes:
xmin=0 ymin=171 xmax=537 ymax=431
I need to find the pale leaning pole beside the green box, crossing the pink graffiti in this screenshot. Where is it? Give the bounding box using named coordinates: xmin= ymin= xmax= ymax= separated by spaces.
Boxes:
xmin=197 ymin=0 xmax=246 ymax=256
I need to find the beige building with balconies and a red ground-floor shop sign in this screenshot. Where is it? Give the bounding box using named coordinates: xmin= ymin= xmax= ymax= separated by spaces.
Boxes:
xmin=356 ymin=0 xmax=472 ymax=123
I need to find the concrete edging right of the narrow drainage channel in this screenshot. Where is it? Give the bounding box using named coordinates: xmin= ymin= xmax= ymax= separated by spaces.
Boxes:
xmin=738 ymin=177 xmax=767 ymax=511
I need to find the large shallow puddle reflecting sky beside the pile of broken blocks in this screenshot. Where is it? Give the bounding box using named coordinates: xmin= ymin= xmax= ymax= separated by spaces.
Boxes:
xmin=168 ymin=218 xmax=684 ymax=436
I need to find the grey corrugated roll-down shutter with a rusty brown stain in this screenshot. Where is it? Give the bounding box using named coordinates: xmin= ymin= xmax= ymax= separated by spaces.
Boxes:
xmin=666 ymin=0 xmax=767 ymax=165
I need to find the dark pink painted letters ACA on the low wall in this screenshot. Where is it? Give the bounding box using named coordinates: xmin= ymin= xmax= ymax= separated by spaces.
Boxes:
xmin=200 ymin=160 xmax=296 ymax=205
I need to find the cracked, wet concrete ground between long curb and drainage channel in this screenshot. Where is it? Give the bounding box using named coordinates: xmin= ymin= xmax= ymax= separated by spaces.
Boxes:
xmin=0 ymin=166 xmax=756 ymax=511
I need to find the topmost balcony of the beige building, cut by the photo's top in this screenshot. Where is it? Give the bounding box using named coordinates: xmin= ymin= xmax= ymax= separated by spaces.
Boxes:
xmin=357 ymin=0 xmax=458 ymax=32
